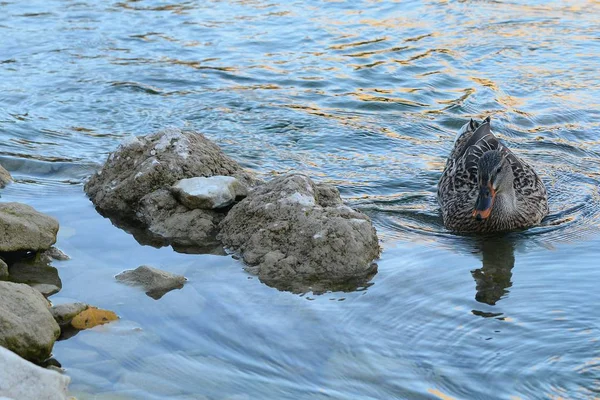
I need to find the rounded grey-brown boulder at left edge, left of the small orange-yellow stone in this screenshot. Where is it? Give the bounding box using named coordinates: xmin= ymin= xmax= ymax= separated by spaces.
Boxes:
xmin=0 ymin=282 xmax=60 ymax=362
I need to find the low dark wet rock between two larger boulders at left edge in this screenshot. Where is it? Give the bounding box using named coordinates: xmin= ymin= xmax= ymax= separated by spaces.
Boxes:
xmin=8 ymin=260 xmax=62 ymax=297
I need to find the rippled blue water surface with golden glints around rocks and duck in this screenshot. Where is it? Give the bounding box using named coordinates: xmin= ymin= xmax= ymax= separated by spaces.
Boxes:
xmin=0 ymin=0 xmax=600 ymax=399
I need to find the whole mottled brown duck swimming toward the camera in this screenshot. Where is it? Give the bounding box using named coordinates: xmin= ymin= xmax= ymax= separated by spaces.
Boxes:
xmin=438 ymin=117 xmax=548 ymax=232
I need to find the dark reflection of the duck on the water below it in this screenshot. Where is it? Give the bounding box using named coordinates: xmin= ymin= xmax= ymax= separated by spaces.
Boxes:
xmin=471 ymin=236 xmax=515 ymax=306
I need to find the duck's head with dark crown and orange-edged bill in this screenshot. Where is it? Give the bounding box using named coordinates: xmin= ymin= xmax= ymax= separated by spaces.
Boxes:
xmin=473 ymin=150 xmax=514 ymax=221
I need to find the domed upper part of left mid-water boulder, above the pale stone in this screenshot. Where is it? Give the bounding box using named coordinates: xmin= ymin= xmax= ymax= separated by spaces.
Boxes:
xmin=85 ymin=129 xmax=254 ymax=219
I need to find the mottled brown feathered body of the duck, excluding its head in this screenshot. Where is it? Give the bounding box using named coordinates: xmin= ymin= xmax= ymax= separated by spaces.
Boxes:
xmin=438 ymin=120 xmax=548 ymax=232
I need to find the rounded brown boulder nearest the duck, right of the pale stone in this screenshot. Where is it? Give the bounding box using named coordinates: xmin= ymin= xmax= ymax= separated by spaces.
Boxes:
xmin=219 ymin=174 xmax=380 ymax=291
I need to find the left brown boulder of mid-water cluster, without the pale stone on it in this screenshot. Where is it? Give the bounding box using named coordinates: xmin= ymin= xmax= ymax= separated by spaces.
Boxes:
xmin=85 ymin=129 xmax=255 ymax=252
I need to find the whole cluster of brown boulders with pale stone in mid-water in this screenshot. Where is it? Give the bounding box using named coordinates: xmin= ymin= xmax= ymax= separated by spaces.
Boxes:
xmin=85 ymin=130 xmax=380 ymax=292
